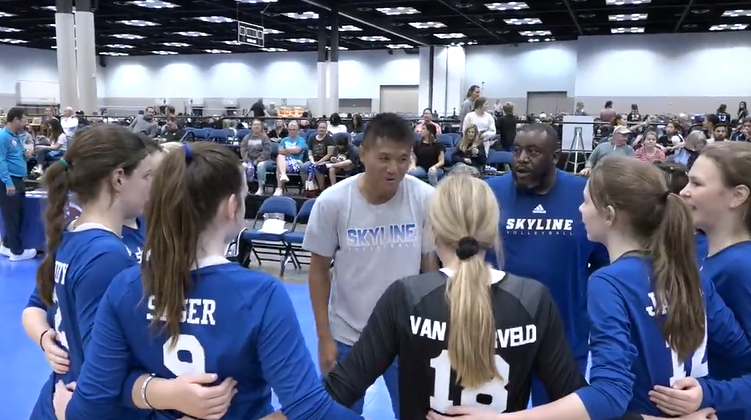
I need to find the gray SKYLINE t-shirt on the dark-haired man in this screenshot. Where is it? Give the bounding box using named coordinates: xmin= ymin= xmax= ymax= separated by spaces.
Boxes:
xmin=303 ymin=175 xmax=434 ymax=345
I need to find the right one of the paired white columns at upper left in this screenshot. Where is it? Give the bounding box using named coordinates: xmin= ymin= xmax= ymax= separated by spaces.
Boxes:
xmin=76 ymin=0 xmax=99 ymax=115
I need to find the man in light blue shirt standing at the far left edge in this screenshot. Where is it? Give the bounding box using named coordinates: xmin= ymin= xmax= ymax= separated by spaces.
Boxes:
xmin=0 ymin=107 xmax=36 ymax=261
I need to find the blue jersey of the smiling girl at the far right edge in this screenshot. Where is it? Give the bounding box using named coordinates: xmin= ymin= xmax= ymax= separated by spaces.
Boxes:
xmin=699 ymin=242 xmax=751 ymax=420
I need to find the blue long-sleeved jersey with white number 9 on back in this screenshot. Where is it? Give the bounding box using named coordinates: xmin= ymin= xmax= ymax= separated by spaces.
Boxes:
xmin=66 ymin=257 xmax=361 ymax=420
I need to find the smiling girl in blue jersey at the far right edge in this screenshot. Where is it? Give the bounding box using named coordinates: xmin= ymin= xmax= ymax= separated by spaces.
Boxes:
xmin=657 ymin=142 xmax=751 ymax=420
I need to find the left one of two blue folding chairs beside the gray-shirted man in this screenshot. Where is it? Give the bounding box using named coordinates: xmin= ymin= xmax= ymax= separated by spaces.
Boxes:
xmin=240 ymin=197 xmax=297 ymax=275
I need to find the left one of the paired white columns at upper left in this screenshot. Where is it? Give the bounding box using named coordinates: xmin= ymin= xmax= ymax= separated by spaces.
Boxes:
xmin=55 ymin=0 xmax=78 ymax=109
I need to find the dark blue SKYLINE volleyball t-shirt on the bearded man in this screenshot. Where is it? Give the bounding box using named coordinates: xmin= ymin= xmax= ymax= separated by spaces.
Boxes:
xmin=487 ymin=171 xmax=609 ymax=360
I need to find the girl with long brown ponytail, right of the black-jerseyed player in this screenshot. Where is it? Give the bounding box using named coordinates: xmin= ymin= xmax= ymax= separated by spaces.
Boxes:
xmin=434 ymin=157 xmax=751 ymax=420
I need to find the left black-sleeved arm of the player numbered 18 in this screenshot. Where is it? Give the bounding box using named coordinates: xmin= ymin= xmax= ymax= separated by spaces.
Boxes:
xmin=323 ymin=281 xmax=405 ymax=407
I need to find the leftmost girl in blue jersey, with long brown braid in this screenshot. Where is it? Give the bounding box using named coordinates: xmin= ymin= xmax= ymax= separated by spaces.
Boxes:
xmin=30 ymin=125 xmax=161 ymax=420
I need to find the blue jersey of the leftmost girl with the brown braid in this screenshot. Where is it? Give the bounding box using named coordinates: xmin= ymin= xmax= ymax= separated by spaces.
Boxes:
xmin=31 ymin=224 xmax=133 ymax=420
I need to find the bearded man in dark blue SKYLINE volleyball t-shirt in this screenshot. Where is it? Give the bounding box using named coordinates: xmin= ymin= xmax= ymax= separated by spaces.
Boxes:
xmin=488 ymin=124 xmax=609 ymax=406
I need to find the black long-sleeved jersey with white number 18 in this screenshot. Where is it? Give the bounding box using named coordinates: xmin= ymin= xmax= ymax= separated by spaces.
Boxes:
xmin=324 ymin=271 xmax=587 ymax=420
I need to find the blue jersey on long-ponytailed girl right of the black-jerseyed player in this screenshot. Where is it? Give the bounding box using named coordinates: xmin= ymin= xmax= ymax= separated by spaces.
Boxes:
xmin=577 ymin=254 xmax=751 ymax=420
